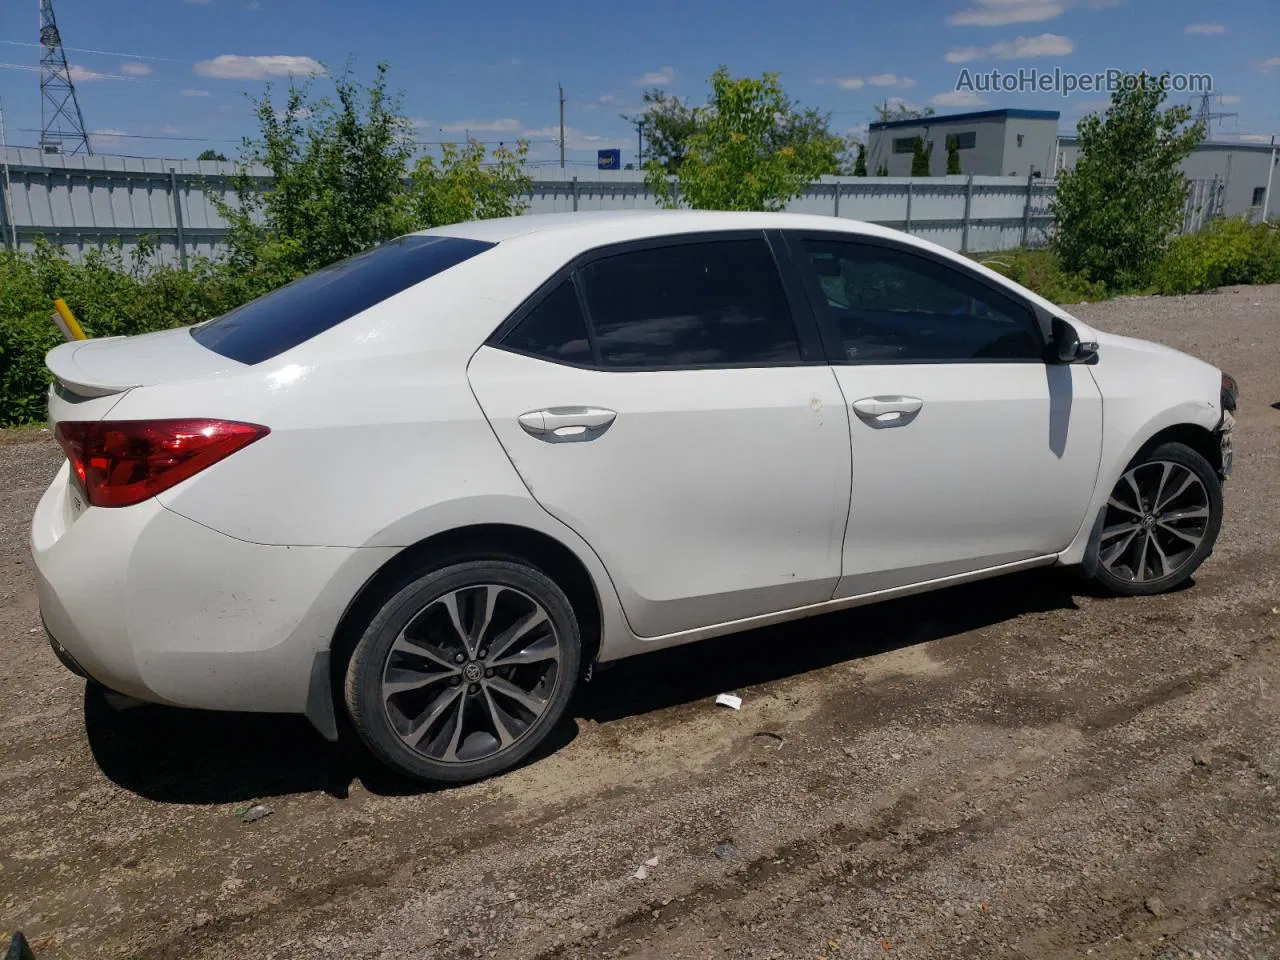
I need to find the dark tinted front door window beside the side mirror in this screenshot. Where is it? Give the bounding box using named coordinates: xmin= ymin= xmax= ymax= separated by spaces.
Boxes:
xmin=803 ymin=241 xmax=1042 ymax=364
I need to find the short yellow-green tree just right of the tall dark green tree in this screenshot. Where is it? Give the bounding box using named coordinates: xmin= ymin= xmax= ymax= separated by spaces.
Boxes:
xmin=410 ymin=140 xmax=532 ymax=229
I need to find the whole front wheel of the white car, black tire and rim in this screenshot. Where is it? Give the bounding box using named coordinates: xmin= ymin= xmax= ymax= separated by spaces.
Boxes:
xmin=1087 ymin=443 xmax=1222 ymax=596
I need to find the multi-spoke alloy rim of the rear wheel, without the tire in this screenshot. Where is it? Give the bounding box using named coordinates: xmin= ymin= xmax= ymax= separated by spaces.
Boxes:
xmin=381 ymin=584 xmax=563 ymax=763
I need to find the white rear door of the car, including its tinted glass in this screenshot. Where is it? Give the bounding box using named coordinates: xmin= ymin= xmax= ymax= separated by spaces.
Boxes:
xmin=467 ymin=232 xmax=850 ymax=636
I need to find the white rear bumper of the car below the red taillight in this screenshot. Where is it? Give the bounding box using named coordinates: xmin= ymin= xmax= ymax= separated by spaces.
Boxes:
xmin=31 ymin=465 xmax=394 ymax=713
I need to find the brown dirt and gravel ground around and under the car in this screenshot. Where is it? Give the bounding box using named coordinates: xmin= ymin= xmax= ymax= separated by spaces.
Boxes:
xmin=0 ymin=287 xmax=1280 ymax=960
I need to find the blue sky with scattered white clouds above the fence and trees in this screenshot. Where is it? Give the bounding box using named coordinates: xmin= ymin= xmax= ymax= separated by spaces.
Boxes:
xmin=0 ymin=0 xmax=1280 ymax=165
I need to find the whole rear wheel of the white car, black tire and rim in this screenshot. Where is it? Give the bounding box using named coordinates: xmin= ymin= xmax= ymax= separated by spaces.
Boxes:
xmin=344 ymin=559 xmax=582 ymax=783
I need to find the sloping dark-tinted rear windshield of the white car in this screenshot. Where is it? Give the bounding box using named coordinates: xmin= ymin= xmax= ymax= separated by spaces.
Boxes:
xmin=191 ymin=237 xmax=493 ymax=364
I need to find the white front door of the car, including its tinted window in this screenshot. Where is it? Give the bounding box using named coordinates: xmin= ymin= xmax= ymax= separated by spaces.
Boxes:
xmin=788 ymin=233 xmax=1102 ymax=596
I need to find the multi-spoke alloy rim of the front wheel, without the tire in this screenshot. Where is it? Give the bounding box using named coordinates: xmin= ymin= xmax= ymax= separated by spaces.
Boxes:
xmin=1098 ymin=460 xmax=1211 ymax=582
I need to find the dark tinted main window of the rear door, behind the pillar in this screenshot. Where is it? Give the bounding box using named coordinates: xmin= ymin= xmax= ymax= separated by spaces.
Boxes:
xmin=581 ymin=239 xmax=800 ymax=367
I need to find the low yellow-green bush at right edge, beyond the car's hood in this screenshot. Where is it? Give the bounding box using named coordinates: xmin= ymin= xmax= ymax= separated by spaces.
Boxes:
xmin=1153 ymin=219 xmax=1280 ymax=294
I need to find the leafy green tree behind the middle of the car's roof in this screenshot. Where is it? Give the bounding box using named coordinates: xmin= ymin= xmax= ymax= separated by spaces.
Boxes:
xmin=645 ymin=67 xmax=841 ymax=210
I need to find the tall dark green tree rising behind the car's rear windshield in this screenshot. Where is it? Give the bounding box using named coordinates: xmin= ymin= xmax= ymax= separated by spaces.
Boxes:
xmin=215 ymin=64 xmax=412 ymax=283
